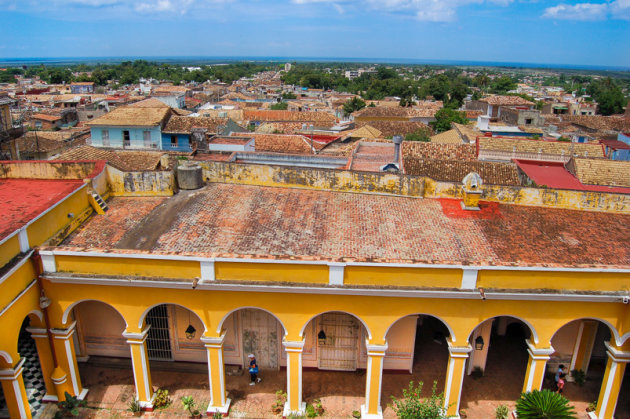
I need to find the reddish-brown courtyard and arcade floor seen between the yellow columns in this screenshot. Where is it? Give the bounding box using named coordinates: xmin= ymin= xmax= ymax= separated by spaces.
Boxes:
xmin=38 ymin=338 xmax=630 ymax=419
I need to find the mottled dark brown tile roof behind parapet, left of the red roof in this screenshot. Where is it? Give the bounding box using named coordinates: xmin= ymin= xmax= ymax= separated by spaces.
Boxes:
xmin=404 ymin=157 xmax=521 ymax=186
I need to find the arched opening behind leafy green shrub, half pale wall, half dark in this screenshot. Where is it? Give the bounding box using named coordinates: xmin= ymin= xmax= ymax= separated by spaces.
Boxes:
xmin=381 ymin=314 xmax=451 ymax=415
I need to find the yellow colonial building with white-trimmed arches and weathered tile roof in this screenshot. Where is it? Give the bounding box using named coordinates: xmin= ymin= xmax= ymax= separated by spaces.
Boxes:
xmin=0 ymin=161 xmax=630 ymax=419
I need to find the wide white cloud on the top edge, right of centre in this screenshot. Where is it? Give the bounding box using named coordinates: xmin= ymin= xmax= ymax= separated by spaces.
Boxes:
xmin=291 ymin=0 xmax=516 ymax=22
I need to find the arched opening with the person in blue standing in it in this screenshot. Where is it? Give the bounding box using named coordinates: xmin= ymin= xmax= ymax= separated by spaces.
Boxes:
xmin=219 ymin=307 xmax=286 ymax=412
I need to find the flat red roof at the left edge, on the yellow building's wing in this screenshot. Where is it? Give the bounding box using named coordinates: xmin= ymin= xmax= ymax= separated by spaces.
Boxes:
xmin=0 ymin=179 xmax=83 ymax=240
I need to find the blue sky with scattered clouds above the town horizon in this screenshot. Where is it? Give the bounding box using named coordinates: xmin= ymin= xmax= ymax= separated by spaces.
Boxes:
xmin=0 ymin=0 xmax=630 ymax=67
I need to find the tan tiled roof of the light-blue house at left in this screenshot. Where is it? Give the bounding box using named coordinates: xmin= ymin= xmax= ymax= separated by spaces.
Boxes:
xmin=86 ymin=105 xmax=171 ymax=127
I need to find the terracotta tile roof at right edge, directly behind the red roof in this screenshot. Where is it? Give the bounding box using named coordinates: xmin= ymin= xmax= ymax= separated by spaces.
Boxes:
xmin=567 ymin=159 xmax=630 ymax=187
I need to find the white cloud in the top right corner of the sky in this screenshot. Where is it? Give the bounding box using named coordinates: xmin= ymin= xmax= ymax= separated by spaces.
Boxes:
xmin=543 ymin=0 xmax=630 ymax=21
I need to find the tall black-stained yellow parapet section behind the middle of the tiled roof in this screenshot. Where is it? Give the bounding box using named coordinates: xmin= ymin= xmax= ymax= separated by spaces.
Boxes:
xmin=197 ymin=161 xmax=424 ymax=197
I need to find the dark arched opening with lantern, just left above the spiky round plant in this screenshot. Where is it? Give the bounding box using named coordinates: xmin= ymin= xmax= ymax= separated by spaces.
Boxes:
xmin=460 ymin=316 xmax=536 ymax=417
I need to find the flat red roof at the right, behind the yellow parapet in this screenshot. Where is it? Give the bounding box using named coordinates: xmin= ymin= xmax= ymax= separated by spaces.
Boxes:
xmin=514 ymin=160 xmax=630 ymax=194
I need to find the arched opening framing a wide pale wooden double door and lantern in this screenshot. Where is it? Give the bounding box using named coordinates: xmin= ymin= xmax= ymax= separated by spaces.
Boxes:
xmin=300 ymin=311 xmax=369 ymax=417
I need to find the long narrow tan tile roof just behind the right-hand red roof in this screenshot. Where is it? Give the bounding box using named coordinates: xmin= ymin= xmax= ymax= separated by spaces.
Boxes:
xmin=478 ymin=137 xmax=605 ymax=157
